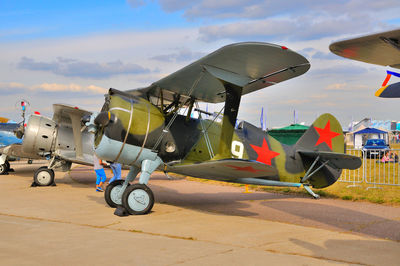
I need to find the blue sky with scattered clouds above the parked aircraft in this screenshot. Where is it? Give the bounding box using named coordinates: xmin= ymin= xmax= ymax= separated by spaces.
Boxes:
xmin=0 ymin=0 xmax=400 ymax=128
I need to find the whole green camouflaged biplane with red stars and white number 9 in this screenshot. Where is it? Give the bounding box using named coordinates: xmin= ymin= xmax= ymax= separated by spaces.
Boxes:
xmin=83 ymin=42 xmax=361 ymax=215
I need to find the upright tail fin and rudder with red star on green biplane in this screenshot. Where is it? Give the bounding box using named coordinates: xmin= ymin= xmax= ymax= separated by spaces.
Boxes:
xmin=294 ymin=114 xmax=346 ymax=188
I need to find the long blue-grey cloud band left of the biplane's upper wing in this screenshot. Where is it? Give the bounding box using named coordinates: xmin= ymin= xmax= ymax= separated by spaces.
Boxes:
xmin=18 ymin=56 xmax=151 ymax=79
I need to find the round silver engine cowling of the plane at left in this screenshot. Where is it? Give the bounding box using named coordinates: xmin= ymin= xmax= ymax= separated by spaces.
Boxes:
xmin=22 ymin=115 xmax=57 ymax=155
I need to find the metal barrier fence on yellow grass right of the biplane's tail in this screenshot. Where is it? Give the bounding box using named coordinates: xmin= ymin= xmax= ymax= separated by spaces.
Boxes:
xmin=338 ymin=149 xmax=400 ymax=189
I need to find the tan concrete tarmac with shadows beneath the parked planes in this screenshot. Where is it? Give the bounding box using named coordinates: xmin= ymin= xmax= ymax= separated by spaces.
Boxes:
xmin=0 ymin=162 xmax=400 ymax=265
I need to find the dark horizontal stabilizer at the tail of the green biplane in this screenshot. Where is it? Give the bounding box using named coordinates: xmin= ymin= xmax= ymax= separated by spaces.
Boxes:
xmin=297 ymin=150 xmax=362 ymax=170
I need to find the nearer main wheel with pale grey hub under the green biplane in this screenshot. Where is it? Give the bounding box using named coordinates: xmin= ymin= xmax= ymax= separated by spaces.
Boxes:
xmin=122 ymin=184 xmax=154 ymax=215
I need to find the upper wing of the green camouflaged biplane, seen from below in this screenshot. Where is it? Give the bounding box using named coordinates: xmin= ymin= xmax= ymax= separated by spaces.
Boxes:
xmin=128 ymin=42 xmax=310 ymax=103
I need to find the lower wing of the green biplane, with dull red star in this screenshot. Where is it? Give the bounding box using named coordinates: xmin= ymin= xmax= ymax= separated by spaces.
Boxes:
xmin=168 ymin=159 xmax=277 ymax=180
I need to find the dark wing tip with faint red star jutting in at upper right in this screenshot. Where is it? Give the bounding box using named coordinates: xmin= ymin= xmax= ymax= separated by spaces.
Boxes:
xmin=329 ymin=29 xmax=400 ymax=68
